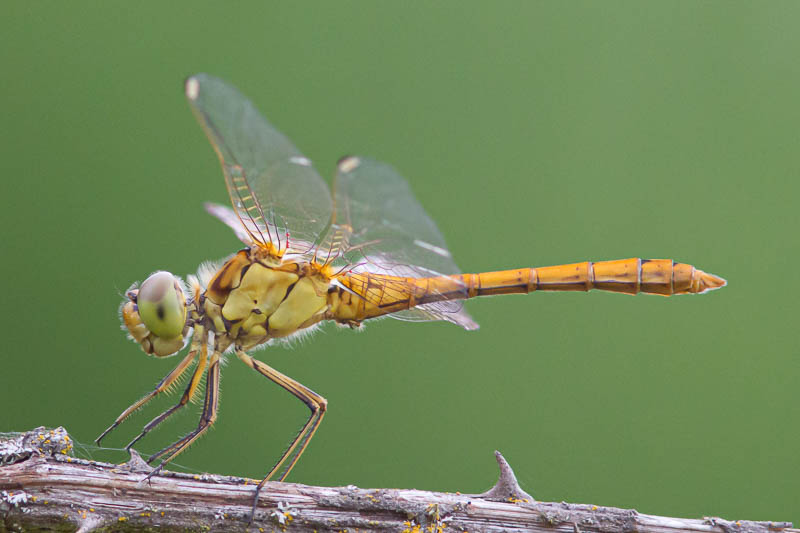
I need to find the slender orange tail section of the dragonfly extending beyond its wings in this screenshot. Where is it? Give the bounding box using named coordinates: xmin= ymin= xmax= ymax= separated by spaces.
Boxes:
xmin=460 ymin=257 xmax=726 ymax=298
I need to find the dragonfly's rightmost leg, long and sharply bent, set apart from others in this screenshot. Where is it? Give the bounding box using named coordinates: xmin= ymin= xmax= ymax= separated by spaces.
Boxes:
xmin=236 ymin=349 xmax=328 ymax=522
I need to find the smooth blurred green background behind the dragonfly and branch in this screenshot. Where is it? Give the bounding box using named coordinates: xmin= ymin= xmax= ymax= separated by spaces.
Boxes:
xmin=0 ymin=2 xmax=800 ymax=523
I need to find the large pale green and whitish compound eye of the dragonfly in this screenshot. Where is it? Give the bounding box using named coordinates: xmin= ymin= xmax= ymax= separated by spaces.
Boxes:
xmin=136 ymin=272 xmax=186 ymax=339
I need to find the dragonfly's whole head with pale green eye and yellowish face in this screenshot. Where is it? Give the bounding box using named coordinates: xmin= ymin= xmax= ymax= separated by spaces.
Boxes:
xmin=120 ymin=271 xmax=189 ymax=357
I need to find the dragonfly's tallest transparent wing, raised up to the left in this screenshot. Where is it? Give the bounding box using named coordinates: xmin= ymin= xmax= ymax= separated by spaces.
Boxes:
xmin=186 ymin=74 xmax=332 ymax=252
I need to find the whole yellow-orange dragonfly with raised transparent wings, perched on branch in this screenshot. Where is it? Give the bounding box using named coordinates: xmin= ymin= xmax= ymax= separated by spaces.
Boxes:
xmin=96 ymin=74 xmax=726 ymax=520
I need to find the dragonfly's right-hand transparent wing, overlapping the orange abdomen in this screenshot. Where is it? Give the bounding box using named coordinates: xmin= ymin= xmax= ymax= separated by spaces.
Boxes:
xmin=319 ymin=157 xmax=477 ymax=329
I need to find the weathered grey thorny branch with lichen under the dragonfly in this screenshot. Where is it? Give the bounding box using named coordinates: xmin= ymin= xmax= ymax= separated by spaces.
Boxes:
xmin=0 ymin=428 xmax=800 ymax=533
